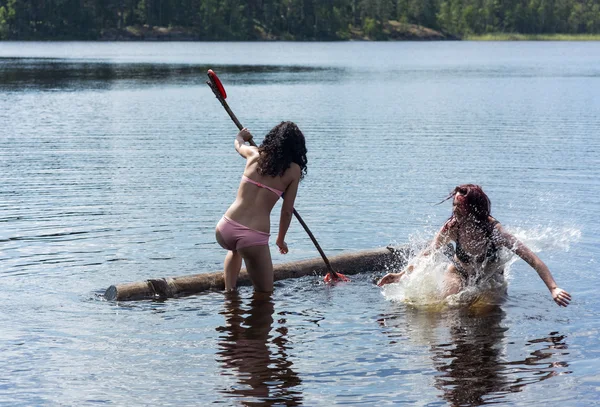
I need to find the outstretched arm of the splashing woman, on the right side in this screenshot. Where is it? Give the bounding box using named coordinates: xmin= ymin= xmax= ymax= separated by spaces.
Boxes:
xmin=496 ymin=225 xmax=571 ymax=307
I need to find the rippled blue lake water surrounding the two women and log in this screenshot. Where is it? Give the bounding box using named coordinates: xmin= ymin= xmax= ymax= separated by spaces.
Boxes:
xmin=0 ymin=42 xmax=600 ymax=406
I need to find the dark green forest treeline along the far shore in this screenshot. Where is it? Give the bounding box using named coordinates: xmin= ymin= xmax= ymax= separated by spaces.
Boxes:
xmin=0 ymin=0 xmax=600 ymax=40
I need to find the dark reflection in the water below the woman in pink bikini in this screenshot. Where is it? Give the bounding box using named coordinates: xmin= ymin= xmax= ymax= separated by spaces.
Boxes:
xmin=217 ymin=292 xmax=302 ymax=406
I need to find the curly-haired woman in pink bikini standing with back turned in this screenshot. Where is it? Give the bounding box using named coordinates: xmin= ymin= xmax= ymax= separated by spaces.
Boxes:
xmin=215 ymin=122 xmax=307 ymax=292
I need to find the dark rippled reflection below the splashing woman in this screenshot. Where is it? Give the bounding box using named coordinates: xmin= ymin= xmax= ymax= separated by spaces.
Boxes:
xmin=379 ymin=306 xmax=572 ymax=406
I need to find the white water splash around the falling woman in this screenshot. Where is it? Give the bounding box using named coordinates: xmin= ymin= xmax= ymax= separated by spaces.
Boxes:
xmin=382 ymin=227 xmax=581 ymax=310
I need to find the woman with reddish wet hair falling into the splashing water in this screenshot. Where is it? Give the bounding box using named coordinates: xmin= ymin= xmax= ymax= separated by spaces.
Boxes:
xmin=377 ymin=184 xmax=571 ymax=307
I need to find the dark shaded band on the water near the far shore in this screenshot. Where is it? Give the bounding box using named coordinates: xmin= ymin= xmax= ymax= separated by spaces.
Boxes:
xmin=0 ymin=58 xmax=341 ymax=90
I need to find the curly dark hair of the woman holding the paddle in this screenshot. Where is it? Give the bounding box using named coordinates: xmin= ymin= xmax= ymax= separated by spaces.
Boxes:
xmin=258 ymin=122 xmax=308 ymax=179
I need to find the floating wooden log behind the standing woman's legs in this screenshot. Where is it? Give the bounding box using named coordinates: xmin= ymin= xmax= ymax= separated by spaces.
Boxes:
xmin=104 ymin=246 xmax=410 ymax=301
